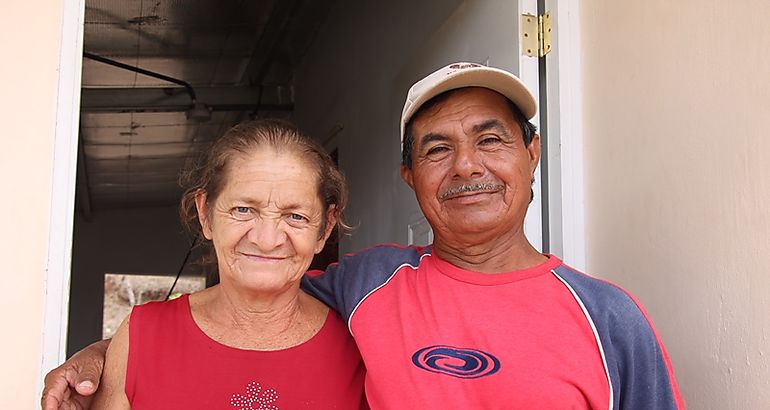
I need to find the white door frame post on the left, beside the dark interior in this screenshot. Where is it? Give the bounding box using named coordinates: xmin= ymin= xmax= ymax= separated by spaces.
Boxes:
xmin=39 ymin=0 xmax=85 ymax=387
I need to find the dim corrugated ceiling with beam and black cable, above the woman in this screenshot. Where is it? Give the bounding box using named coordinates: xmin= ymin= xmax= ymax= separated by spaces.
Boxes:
xmin=77 ymin=0 xmax=333 ymax=216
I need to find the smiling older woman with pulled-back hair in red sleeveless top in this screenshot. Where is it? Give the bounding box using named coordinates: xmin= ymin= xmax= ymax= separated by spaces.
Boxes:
xmin=92 ymin=120 xmax=366 ymax=409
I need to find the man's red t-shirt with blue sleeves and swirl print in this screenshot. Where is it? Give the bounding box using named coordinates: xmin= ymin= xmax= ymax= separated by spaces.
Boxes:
xmin=304 ymin=246 xmax=683 ymax=410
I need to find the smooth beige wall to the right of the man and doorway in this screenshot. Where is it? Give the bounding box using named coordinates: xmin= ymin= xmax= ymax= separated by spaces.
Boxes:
xmin=581 ymin=0 xmax=770 ymax=409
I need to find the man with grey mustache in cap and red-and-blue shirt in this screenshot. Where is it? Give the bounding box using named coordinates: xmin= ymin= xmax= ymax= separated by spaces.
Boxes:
xmin=46 ymin=63 xmax=684 ymax=409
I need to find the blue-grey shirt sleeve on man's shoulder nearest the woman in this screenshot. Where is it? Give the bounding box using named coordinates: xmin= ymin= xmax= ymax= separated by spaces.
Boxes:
xmin=302 ymin=245 xmax=429 ymax=322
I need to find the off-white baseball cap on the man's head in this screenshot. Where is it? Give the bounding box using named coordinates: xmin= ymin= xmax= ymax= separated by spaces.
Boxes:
xmin=401 ymin=63 xmax=537 ymax=143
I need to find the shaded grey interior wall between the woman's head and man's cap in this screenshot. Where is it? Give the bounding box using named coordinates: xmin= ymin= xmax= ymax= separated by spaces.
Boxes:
xmin=295 ymin=0 xmax=518 ymax=251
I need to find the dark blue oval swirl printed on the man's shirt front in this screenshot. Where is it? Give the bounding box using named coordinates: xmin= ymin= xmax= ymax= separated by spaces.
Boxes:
xmin=412 ymin=345 xmax=500 ymax=379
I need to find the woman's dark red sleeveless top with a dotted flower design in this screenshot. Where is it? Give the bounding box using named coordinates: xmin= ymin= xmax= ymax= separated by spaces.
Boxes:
xmin=126 ymin=295 xmax=368 ymax=410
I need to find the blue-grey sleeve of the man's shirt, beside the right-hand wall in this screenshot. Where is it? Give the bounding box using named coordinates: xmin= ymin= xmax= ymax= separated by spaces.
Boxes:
xmin=556 ymin=266 xmax=684 ymax=410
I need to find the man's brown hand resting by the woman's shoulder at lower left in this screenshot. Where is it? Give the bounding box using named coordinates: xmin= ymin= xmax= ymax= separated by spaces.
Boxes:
xmin=41 ymin=340 xmax=110 ymax=410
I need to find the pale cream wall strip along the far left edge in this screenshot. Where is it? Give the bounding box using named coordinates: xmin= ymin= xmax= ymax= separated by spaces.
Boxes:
xmin=0 ymin=0 xmax=63 ymax=409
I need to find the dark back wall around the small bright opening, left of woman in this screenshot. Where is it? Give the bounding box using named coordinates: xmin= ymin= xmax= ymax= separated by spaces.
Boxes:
xmin=67 ymin=207 xmax=190 ymax=356
